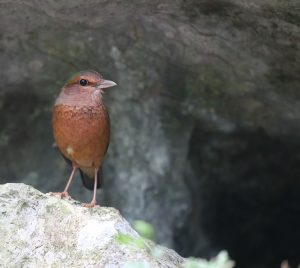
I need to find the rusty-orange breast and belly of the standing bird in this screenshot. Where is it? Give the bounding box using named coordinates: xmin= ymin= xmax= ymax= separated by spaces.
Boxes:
xmin=52 ymin=105 xmax=110 ymax=167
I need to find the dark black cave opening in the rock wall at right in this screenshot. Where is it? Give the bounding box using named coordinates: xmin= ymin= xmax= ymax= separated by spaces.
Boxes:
xmin=174 ymin=126 xmax=300 ymax=268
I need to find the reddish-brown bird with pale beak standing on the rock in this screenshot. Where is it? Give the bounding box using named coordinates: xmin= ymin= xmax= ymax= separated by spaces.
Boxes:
xmin=52 ymin=71 xmax=117 ymax=207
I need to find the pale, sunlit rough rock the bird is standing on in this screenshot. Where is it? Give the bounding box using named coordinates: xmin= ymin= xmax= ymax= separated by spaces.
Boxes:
xmin=0 ymin=184 xmax=184 ymax=267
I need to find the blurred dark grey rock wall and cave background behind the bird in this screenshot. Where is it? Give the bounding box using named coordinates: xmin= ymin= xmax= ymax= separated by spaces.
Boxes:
xmin=0 ymin=0 xmax=300 ymax=268
